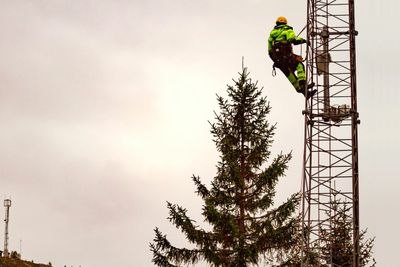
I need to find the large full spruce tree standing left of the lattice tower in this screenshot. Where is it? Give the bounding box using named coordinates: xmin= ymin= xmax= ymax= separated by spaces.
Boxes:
xmin=150 ymin=68 xmax=298 ymax=267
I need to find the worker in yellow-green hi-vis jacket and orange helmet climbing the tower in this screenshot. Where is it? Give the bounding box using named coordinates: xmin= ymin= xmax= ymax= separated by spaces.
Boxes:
xmin=268 ymin=17 xmax=317 ymax=98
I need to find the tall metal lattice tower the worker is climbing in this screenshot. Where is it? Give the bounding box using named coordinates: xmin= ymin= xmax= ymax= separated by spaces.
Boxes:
xmin=301 ymin=0 xmax=360 ymax=267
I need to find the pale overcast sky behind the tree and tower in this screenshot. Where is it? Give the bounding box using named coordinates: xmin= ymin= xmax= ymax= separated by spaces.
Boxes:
xmin=0 ymin=0 xmax=400 ymax=267
